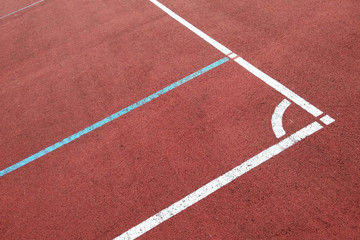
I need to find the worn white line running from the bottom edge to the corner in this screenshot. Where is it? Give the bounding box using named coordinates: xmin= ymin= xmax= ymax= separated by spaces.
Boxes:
xmin=115 ymin=122 xmax=323 ymax=240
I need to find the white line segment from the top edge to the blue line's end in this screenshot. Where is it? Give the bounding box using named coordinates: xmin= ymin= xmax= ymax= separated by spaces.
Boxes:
xmin=150 ymin=0 xmax=231 ymax=55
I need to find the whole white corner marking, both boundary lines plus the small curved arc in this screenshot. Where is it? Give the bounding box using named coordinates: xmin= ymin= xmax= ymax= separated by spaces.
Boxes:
xmin=115 ymin=0 xmax=335 ymax=240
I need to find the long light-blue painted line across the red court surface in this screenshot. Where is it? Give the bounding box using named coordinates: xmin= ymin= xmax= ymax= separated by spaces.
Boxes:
xmin=0 ymin=57 xmax=229 ymax=177
